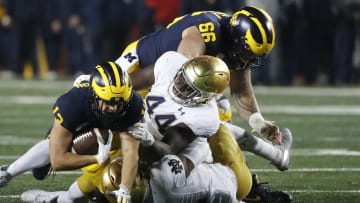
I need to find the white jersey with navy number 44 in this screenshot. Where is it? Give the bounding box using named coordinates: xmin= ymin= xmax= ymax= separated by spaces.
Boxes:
xmin=144 ymin=51 xmax=220 ymax=140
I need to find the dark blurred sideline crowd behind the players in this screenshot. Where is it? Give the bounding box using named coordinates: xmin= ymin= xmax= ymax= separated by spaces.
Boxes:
xmin=0 ymin=0 xmax=360 ymax=86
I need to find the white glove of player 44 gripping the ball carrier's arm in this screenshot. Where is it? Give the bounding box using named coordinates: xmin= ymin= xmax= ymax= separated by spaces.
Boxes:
xmin=127 ymin=122 xmax=154 ymax=147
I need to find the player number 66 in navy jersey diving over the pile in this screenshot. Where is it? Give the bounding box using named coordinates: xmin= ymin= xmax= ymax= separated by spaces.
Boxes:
xmin=73 ymin=6 xmax=292 ymax=201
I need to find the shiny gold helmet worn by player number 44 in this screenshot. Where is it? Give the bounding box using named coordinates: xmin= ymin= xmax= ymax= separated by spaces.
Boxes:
xmin=169 ymin=55 xmax=230 ymax=105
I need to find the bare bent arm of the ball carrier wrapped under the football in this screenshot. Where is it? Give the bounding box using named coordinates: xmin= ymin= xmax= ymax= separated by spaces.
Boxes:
xmin=50 ymin=119 xmax=97 ymax=171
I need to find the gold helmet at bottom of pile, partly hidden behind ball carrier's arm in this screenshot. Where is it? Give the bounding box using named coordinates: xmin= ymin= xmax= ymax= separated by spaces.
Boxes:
xmin=101 ymin=157 xmax=123 ymax=203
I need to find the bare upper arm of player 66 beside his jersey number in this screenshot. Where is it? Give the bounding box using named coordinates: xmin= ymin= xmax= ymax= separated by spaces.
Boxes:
xmin=177 ymin=26 xmax=206 ymax=59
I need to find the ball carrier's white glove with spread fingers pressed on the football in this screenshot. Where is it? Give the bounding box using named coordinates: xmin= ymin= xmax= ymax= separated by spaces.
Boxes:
xmin=94 ymin=128 xmax=113 ymax=164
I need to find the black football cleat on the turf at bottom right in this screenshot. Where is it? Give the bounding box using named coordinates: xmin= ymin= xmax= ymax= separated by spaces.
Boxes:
xmin=243 ymin=174 xmax=292 ymax=203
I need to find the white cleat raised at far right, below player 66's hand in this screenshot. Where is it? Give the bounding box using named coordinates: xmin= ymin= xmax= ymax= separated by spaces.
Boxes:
xmin=271 ymin=128 xmax=292 ymax=171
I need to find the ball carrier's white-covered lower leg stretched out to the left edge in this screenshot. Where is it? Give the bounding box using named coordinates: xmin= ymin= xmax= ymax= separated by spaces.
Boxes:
xmin=0 ymin=139 xmax=50 ymax=187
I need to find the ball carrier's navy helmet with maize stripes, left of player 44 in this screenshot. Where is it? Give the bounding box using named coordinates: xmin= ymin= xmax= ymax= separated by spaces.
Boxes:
xmin=90 ymin=62 xmax=133 ymax=116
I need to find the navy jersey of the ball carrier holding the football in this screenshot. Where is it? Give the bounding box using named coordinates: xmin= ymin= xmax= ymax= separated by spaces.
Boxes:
xmin=53 ymin=84 xmax=144 ymax=135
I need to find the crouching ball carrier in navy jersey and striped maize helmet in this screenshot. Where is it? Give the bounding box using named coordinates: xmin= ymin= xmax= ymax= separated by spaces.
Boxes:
xmin=0 ymin=62 xmax=144 ymax=202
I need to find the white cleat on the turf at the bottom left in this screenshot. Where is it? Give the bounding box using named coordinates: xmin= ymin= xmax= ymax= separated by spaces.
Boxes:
xmin=21 ymin=189 xmax=60 ymax=203
